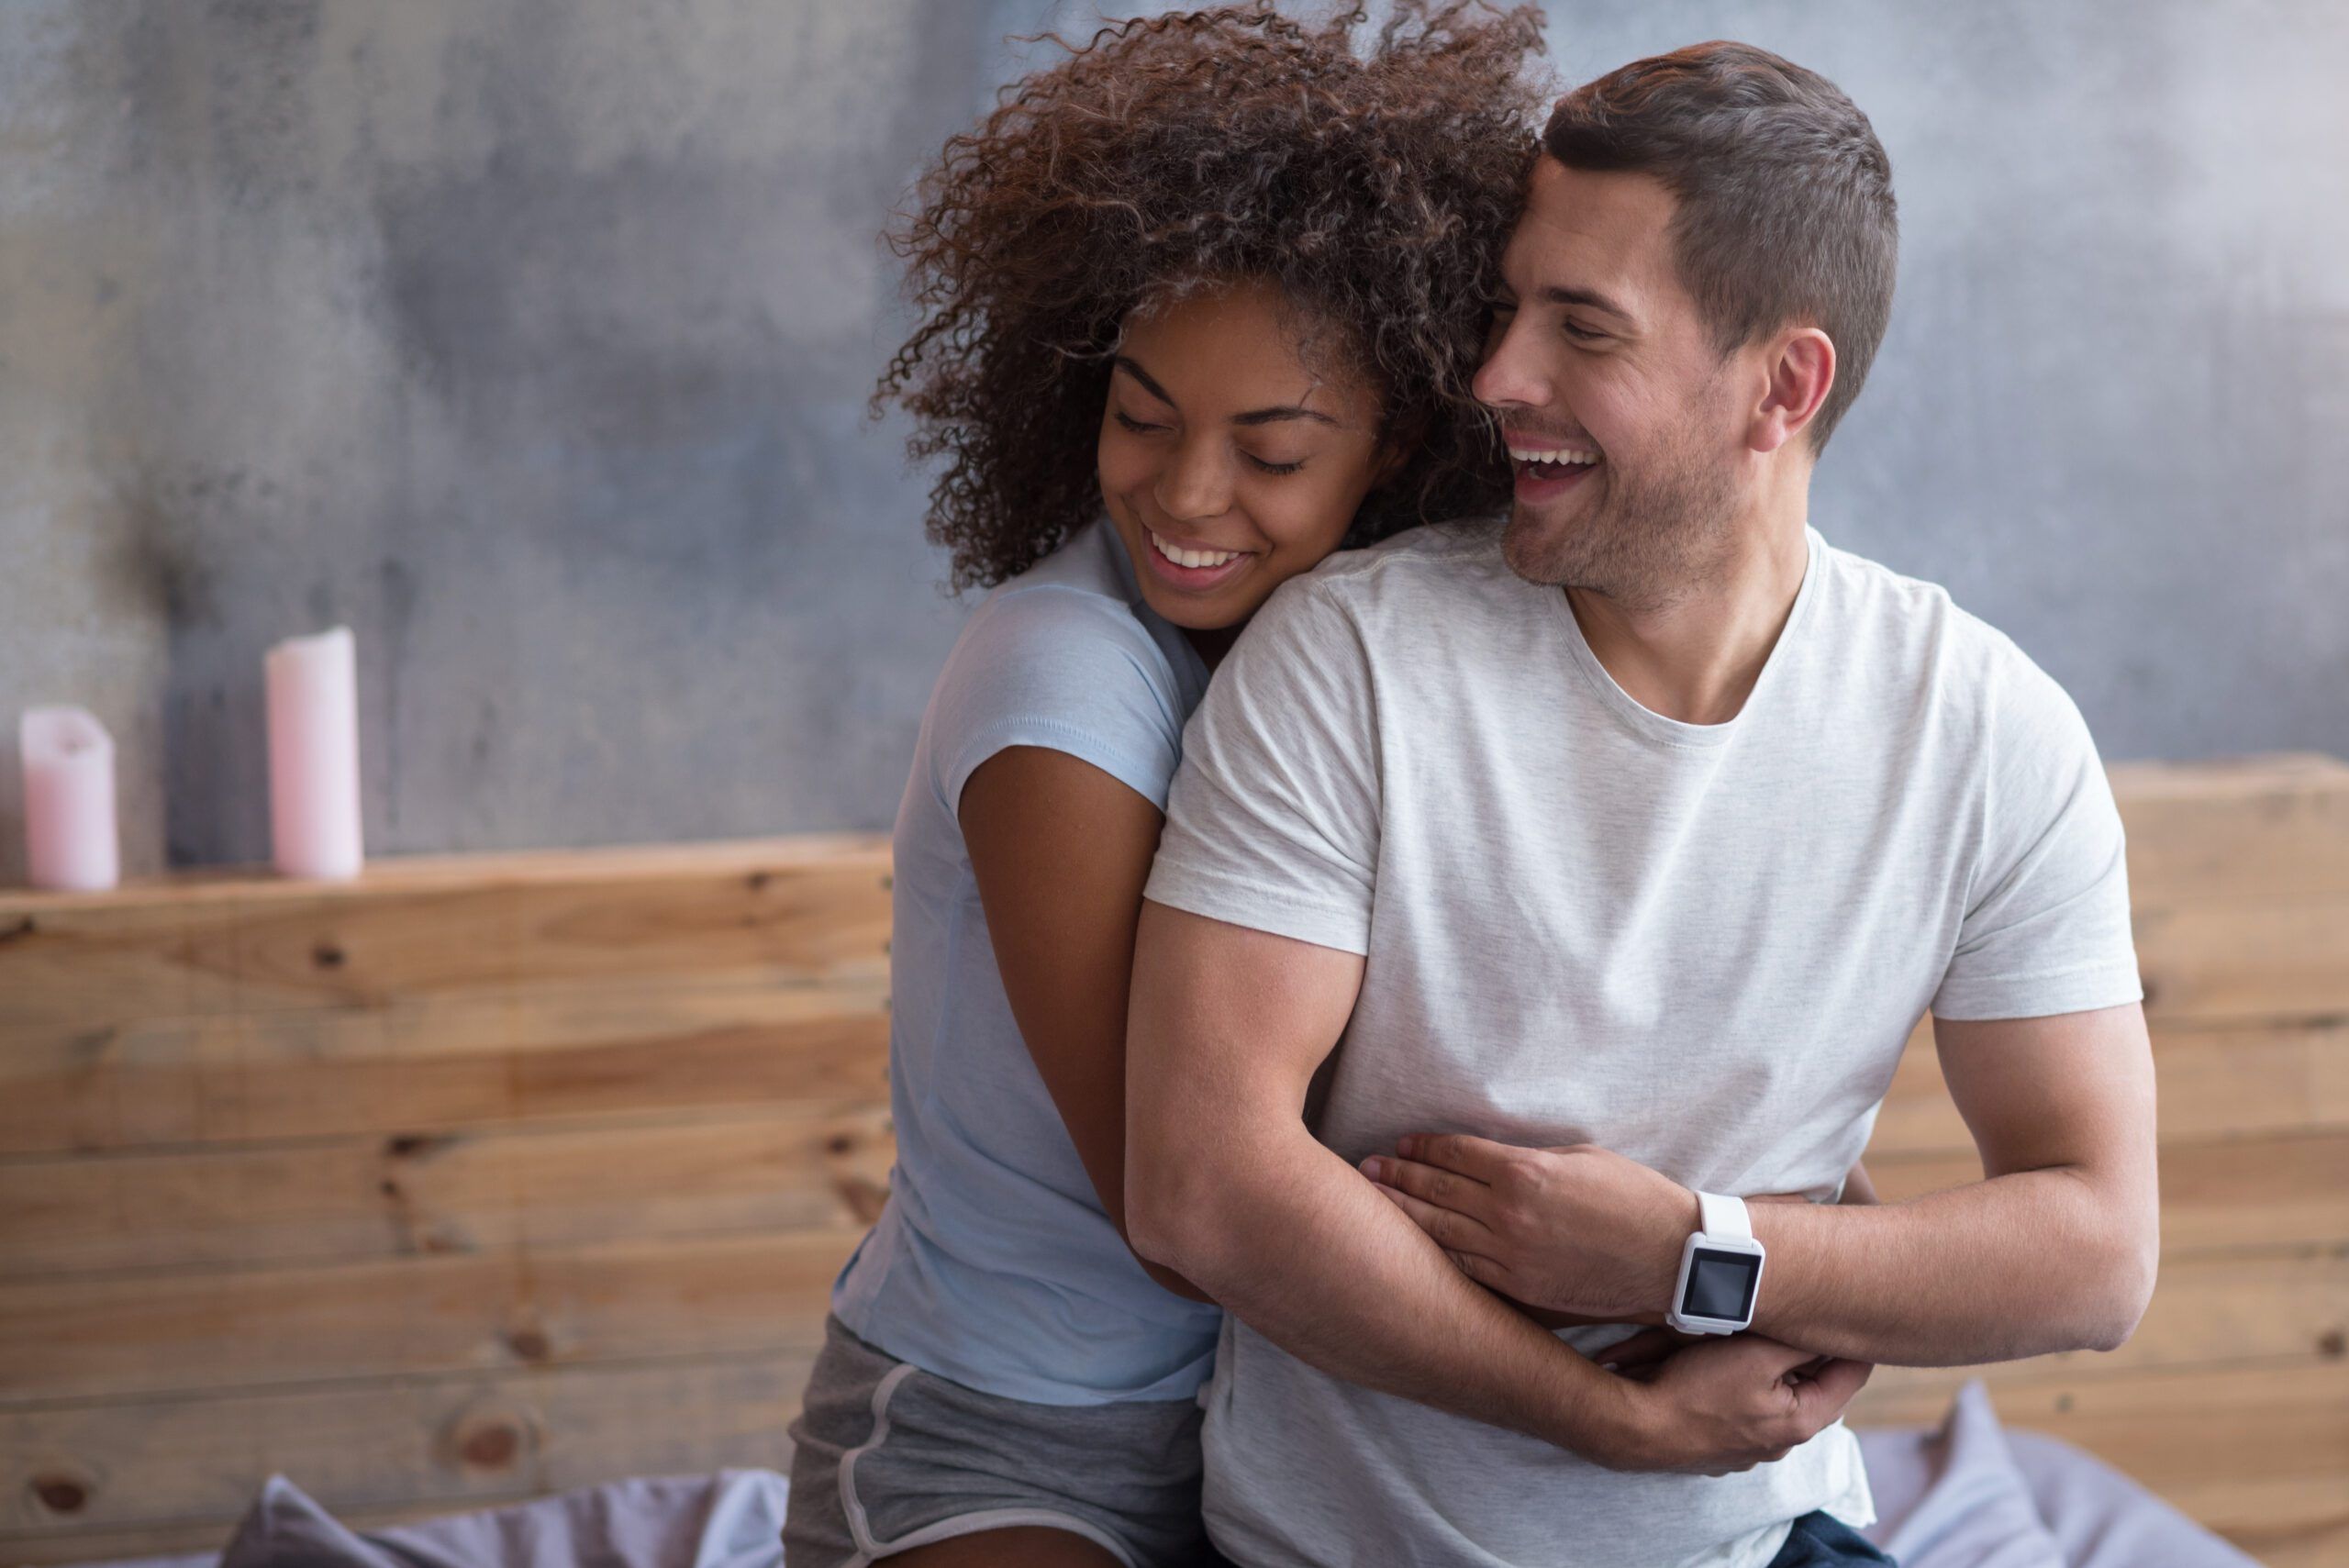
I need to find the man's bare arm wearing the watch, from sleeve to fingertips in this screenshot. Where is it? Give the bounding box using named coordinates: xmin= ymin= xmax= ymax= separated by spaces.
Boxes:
xmin=1367 ymin=1002 xmax=2159 ymax=1366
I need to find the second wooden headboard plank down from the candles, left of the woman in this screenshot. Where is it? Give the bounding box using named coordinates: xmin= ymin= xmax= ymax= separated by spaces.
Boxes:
xmin=0 ymin=979 xmax=888 ymax=1159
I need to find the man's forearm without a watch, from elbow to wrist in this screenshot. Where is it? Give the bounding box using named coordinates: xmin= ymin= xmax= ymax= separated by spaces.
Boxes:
xmin=1134 ymin=1122 xmax=1623 ymax=1451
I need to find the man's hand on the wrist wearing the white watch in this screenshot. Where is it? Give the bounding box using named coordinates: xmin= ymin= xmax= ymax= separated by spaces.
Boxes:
xmin=1363 ymin=1134 xmax=1804 ymax=1326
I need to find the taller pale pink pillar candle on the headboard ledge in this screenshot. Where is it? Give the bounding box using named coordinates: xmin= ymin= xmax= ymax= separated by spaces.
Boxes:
xmin=263 ymin=627 xmax=362 ymax=878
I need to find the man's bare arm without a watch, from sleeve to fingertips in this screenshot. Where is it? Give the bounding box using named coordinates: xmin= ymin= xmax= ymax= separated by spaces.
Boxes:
xmin=1125 ymin=901 xmax=1865 ymax=1474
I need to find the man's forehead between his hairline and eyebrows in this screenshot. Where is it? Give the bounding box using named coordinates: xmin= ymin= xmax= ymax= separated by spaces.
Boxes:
xmin=1501 ymin=155 xmax=1677 ymax=310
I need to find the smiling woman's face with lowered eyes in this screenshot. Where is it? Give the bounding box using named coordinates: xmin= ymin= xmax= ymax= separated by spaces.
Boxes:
xmin=1099 ymin=284 xmax=1386 ymax=631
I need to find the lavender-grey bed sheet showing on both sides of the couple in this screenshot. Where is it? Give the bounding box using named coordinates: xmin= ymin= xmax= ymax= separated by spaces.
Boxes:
xmin=86 ymin=1378 xmax=2257 ymax=1568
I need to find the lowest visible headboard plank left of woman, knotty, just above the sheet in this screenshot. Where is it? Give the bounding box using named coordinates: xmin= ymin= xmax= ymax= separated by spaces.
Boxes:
xmin=0 ymin=1348 xmax=813 ymax=1561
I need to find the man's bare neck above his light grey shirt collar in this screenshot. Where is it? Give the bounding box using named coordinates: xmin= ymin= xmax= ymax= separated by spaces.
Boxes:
xmin=1567 ymin=505 xmax=1811 ymax=723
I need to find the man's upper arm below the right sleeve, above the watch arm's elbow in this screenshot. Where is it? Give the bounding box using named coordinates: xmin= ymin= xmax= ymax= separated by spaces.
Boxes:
xmin=1933 ymin=1002 xmax=2154 ymax=1181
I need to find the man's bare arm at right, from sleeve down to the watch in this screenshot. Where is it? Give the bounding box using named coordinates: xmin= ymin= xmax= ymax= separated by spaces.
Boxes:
xmin=1747 ymin=1002 xmax=2161 ymax=1366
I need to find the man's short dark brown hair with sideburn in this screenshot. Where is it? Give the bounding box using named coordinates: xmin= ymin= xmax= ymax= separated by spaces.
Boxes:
xmin=1541 ymin=42 xmax=1900 ymax=450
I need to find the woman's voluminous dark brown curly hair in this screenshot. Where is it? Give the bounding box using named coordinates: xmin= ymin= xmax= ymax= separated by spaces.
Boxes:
xmin=874 ymin=0 xmax=1541 ymax=589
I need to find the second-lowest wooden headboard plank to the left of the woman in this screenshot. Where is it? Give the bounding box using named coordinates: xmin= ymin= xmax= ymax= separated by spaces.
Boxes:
xmin=0 ymin=1204 xmax=864 ymax=1408
